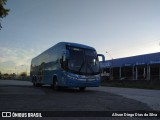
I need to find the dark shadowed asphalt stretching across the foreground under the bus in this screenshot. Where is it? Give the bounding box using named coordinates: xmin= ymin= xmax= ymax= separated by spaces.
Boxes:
xmin=0 ymin=80 xmax=158 ymax=119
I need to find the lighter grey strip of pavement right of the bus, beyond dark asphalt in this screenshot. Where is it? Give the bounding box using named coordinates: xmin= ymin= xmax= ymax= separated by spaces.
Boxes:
xmin=90 ymin=87 xmax=160 ymax=111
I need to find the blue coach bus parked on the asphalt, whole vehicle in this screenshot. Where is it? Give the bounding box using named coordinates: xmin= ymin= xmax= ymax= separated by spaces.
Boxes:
xmin=30 ymin=42 xmax=104 ymax=90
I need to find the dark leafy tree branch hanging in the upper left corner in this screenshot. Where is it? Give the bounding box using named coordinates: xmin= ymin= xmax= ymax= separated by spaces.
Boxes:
xmin=0 ymin=0 xmax=9 ymax=30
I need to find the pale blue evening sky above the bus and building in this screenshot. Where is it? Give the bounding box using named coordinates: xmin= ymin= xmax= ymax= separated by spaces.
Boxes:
xmin=0 ymin=0 xmax=160 ymax=73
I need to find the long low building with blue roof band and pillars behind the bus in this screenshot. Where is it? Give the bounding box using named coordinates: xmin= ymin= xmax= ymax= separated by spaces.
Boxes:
xmin=100 ymin=52 xmax=160 ymax=80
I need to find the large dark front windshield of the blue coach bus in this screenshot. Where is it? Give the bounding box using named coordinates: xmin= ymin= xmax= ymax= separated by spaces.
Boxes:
xmin=67 ymin=46 xmax=99 ymax=75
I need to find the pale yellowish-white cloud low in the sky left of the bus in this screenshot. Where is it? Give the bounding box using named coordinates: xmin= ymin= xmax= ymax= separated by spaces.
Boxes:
xmin=0 ymin=47 xmax=39 ymax=72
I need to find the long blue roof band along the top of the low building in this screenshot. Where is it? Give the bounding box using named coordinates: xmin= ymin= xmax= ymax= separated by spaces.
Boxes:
xmin=101 ymin=52 xmax=160 ymax=67
